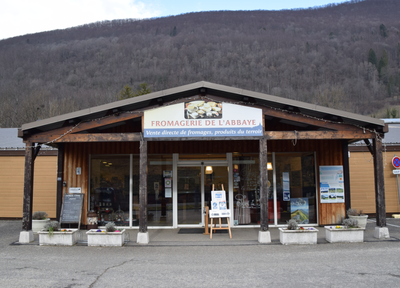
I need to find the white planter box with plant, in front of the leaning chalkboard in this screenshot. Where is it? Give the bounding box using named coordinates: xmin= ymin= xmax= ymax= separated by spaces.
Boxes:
xmin=38 ymin=221 xmax=78 ymax=246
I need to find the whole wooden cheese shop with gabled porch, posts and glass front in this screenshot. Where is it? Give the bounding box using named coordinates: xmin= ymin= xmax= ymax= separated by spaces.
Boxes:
xmin=19 ymin=82 xmax=387 ymax=242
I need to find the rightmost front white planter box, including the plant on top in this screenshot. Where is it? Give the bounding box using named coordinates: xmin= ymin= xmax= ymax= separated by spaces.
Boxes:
xmin=325 ymin=218 xmax=364 ymax=243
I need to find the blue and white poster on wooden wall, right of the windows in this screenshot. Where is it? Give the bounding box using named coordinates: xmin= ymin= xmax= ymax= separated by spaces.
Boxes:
xmin=319 ymin=165 xmax=344 ymax=203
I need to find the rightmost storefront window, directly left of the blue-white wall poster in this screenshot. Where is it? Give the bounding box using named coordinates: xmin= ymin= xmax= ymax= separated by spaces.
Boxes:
xmin=274 ymin=153 xmax=317 ymax=224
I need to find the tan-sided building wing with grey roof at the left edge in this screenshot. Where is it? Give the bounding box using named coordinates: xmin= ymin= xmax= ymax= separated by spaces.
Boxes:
xmin=0 ymin=128 xmax=57 ymax=219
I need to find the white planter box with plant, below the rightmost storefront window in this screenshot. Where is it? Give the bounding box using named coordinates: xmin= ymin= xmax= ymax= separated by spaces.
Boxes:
xmin=279 ymin=219 xmax=318 ymax=245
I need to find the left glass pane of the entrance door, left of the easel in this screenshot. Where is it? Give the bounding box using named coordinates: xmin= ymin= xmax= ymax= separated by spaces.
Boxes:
xmin=178 ymin=166 xmax=204 ymax=225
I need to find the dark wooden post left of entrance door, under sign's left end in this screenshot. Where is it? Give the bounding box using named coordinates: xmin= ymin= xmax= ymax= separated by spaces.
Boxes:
xmin=139 ymin=139 xmax=147 ymax=233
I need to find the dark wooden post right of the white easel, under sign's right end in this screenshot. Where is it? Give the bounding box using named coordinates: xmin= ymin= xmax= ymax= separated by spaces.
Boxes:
xmin=260 ymin=138 xmax=268 ymax=231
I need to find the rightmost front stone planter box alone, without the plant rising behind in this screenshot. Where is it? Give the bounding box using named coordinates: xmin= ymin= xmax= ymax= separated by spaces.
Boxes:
xmin=324 ymin=226 xmax=364 ymax=243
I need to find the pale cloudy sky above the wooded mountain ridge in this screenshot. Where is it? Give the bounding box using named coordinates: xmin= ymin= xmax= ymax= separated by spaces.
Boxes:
xmin=0 ymin=0 xmax=347 ymax=39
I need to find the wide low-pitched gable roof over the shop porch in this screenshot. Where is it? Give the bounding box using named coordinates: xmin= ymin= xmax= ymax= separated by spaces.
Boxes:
xmin=21 ymin=81 xmax=385 ymax=134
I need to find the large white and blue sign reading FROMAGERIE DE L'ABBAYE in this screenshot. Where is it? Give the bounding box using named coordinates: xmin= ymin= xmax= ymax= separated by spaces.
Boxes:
xmin=144 ymin=100 xmax=263 ymax=138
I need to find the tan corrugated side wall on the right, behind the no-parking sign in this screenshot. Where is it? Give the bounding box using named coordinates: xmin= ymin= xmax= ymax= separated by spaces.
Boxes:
xmin=349 ymin=151 xmax=400 ymax=213
